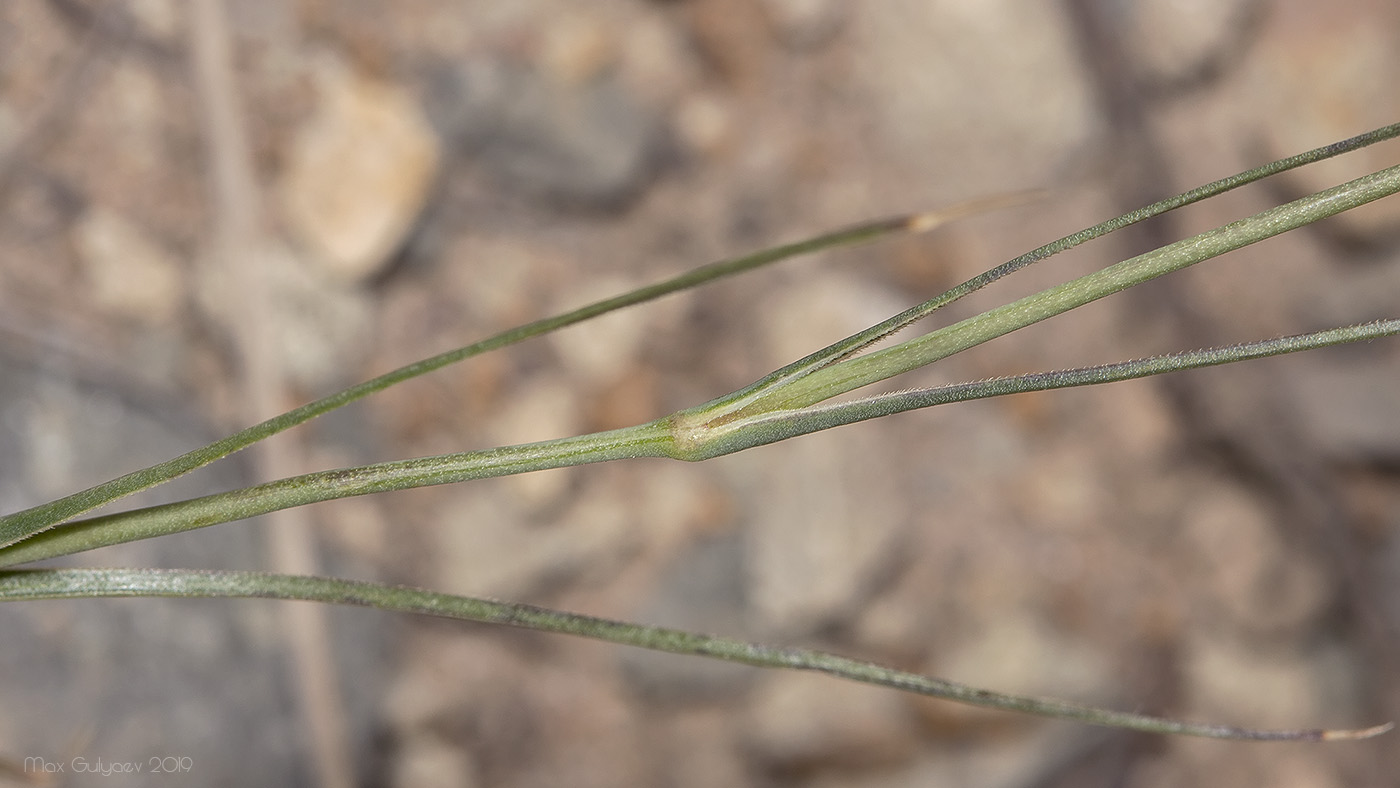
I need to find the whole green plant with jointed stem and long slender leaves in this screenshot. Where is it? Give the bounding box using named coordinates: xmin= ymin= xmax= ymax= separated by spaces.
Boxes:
xmin=0 ymin=125 xmax=1400 ymax=739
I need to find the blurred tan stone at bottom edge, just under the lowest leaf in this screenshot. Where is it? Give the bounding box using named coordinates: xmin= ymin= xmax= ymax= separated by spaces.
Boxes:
xmin=743 ymin=672 xmax=918 ymax=773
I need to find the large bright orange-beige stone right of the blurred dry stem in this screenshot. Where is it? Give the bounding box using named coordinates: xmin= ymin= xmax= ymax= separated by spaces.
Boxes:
xmin=280 ymin=57 xmax=440 ymax=281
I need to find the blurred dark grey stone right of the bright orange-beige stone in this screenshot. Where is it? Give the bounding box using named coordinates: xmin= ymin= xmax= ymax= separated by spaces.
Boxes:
xmin=430 ymin=60 xmax=658 ymax=209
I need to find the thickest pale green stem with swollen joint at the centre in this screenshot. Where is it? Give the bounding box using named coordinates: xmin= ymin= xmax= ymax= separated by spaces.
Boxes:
xmin=0 ymin=173 xmax=1400 ymax=567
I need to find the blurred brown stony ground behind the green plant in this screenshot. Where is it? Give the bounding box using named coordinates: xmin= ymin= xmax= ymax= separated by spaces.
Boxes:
xmin=0 ymin=0 xmax=1400 ymax=788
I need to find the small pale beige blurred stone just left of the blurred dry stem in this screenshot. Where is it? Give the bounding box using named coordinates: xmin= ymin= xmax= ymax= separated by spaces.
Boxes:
xmin=73 ymin=207 xmax=185 ymax=325
